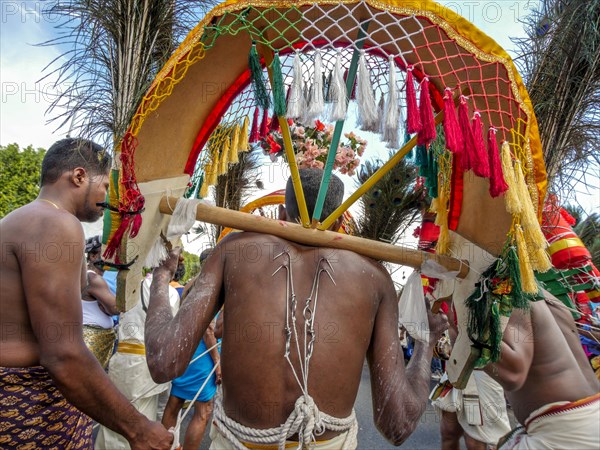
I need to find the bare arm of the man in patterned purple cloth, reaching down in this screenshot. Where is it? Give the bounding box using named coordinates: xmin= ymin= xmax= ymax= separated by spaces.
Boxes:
xmin=19 ymin=216 xmax=172 ymax=449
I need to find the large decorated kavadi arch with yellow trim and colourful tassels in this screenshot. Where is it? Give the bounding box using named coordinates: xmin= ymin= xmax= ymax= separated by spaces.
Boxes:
xmin=104 ymin=0 xmax=549 ymax=386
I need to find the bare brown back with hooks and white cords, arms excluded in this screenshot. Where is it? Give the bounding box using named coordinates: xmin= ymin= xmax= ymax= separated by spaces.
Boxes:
xmin=222 ymin=233 xmax=384 ymax=428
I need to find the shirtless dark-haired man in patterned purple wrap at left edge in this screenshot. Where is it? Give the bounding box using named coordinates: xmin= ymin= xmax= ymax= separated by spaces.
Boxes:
xmin=0 ymin=139 xmax=173 ymax=450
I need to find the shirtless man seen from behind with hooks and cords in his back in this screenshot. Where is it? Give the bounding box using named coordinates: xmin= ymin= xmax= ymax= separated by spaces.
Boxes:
xmin=146 ymin=169 xmax=447 ymax=449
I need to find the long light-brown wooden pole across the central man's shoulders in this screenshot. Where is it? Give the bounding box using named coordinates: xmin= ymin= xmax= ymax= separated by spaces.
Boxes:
xmin=159 ymin=196 xmax=469 ymax=278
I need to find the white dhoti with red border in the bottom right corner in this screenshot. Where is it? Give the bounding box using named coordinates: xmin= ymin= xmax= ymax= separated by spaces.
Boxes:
xmin=498 ymin=394 xmax=600 ymax=450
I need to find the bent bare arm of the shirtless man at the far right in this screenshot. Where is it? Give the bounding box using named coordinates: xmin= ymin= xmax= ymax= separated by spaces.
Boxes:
xmin=484 ymin=309 xmax=533 ymax=392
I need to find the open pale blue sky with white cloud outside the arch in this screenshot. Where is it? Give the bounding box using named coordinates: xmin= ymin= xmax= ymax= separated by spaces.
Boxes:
xmin=0 ymin=0 xmax=600 ymax=214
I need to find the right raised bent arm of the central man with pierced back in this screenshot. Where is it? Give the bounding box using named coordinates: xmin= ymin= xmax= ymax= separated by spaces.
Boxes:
xmin=367 ymin=270 xmax=447 ymax=445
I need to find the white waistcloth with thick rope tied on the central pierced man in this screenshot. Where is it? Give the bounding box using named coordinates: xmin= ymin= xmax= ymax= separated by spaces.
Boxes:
xmin=210 ymin=395 xmax=358 ymax=450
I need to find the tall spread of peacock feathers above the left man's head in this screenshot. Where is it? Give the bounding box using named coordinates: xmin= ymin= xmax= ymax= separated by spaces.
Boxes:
xmin=41 ymin=0 xmax=217 ymax=147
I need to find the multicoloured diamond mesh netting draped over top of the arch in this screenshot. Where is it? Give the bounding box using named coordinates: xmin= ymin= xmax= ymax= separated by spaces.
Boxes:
xmin=178 ymin=2 xmax=537 ymax=192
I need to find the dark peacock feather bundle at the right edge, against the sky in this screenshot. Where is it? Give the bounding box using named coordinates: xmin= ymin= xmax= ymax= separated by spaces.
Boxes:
xmin=515 ymin=0 xmax=600 ymax=200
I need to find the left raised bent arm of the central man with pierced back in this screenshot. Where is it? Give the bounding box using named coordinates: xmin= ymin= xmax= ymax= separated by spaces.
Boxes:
xmin=145 ymin=245 xmax=224 ymax=383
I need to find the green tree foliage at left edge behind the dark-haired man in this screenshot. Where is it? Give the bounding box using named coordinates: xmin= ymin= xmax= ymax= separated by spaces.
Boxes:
xmin=0 ymin=144 xmax=46 ymax=218
